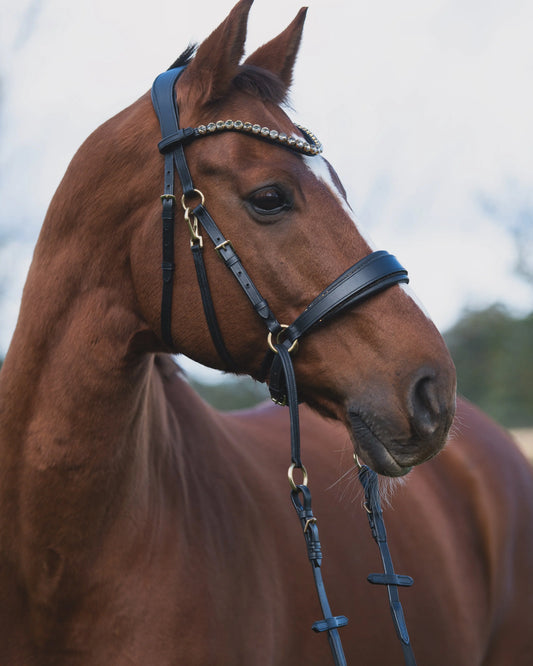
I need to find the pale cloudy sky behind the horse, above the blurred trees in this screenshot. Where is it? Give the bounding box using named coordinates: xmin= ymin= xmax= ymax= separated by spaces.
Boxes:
xmin=0 ymin=0 xmax=533 ymax=374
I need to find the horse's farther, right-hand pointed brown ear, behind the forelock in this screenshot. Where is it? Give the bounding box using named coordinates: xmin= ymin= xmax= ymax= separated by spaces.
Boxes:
xmin=246 ymin=7 xmax=307 ymax=90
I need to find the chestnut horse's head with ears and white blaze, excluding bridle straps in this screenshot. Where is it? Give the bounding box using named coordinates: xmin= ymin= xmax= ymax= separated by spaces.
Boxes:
xmin=122 ymin=0 xmax=455 ymax=476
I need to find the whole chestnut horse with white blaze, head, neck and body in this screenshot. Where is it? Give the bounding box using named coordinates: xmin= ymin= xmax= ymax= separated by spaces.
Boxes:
xmin=0 ymin=0 xmax=533 ymax=666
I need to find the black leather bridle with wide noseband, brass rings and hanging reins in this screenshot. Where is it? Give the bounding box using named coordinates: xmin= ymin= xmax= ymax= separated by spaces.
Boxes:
xmin=152 ymin=67 xmax=415 ymax=666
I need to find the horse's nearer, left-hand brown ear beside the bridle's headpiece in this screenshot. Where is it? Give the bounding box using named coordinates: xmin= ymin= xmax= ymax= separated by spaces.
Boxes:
xmin=179 ymin=0 xmax=253 ymax=104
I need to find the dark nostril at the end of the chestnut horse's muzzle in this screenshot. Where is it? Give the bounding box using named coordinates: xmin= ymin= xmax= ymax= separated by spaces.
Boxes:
xmin=407 ymin=371 xmax=446 ymax=437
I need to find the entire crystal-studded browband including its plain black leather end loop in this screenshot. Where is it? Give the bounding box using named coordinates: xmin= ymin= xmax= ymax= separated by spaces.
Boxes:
xmin=159 ymin=120 xmax=322 ymax=155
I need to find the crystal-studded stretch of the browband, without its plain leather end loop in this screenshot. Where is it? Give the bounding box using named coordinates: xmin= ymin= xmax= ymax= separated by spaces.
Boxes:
xmin=194 ymin=120 xmax=323 ymax=155
